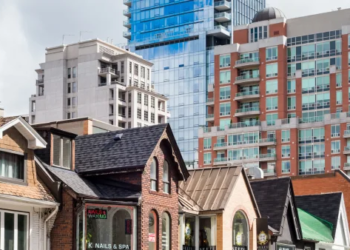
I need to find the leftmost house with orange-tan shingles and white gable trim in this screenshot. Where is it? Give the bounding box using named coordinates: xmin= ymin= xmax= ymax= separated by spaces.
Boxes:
xmin=0 ymin=117 xmax=59 ymax=250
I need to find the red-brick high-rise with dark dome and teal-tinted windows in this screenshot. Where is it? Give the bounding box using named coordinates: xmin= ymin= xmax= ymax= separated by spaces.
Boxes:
xmin=199 ymin=8 xmax=350 ymax=176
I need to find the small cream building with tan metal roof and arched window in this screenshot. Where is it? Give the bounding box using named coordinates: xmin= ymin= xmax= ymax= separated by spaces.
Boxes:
xmin=179 ymin=167 xmax=260 ymax=250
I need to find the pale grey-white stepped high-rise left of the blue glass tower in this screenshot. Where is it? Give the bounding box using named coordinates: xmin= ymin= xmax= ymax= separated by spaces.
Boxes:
xmin=29 ymin=39 xmax=167 ymax=128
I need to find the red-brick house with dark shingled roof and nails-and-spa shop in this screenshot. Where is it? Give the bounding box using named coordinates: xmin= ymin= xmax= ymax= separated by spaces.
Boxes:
xmin=38 ymin=124 xmax=189 ymax=250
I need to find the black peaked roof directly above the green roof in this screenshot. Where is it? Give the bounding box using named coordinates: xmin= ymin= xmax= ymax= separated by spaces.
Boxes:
xmin=295 ymin=193 xmax=342 ymax=237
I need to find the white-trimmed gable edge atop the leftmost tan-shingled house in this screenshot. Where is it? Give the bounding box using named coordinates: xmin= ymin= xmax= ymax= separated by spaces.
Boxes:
xmin=0 ymin=117 xmax=47 ymax=149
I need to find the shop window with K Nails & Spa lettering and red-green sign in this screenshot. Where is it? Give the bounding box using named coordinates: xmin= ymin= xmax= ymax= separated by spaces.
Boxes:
xmin=76 ymin=203 xmax=137 ymax=250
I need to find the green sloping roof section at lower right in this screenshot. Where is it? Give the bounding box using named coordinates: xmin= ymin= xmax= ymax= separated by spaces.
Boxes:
xmin=298 ymin=208 xmax=333 ymax=243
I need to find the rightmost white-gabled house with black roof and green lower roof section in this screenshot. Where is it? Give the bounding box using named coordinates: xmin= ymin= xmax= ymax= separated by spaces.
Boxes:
xmin=295 ymin=192 xmax=350 ymax=250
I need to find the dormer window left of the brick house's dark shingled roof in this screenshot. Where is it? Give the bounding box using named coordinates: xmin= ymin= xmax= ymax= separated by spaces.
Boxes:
xmin=53 ymin=135 xmax=72 ymax=169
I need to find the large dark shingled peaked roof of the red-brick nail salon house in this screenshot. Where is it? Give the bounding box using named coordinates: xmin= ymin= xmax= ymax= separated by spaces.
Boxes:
xmin=75 ymin=124 xmax=188 ymax=178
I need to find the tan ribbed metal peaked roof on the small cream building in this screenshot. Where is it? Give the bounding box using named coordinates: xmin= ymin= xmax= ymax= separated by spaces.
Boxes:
xmin=179 ymin=166 xmax=259 ymax=214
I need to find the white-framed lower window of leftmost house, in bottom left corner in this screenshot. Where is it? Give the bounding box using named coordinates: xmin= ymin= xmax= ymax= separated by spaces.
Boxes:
xmin=0 ymin=210 xmax=29 ymax=250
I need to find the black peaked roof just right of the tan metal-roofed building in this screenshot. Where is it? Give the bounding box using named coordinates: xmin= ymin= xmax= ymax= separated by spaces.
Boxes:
xmin=250 ymin=177 xmax=301 ymax=239
